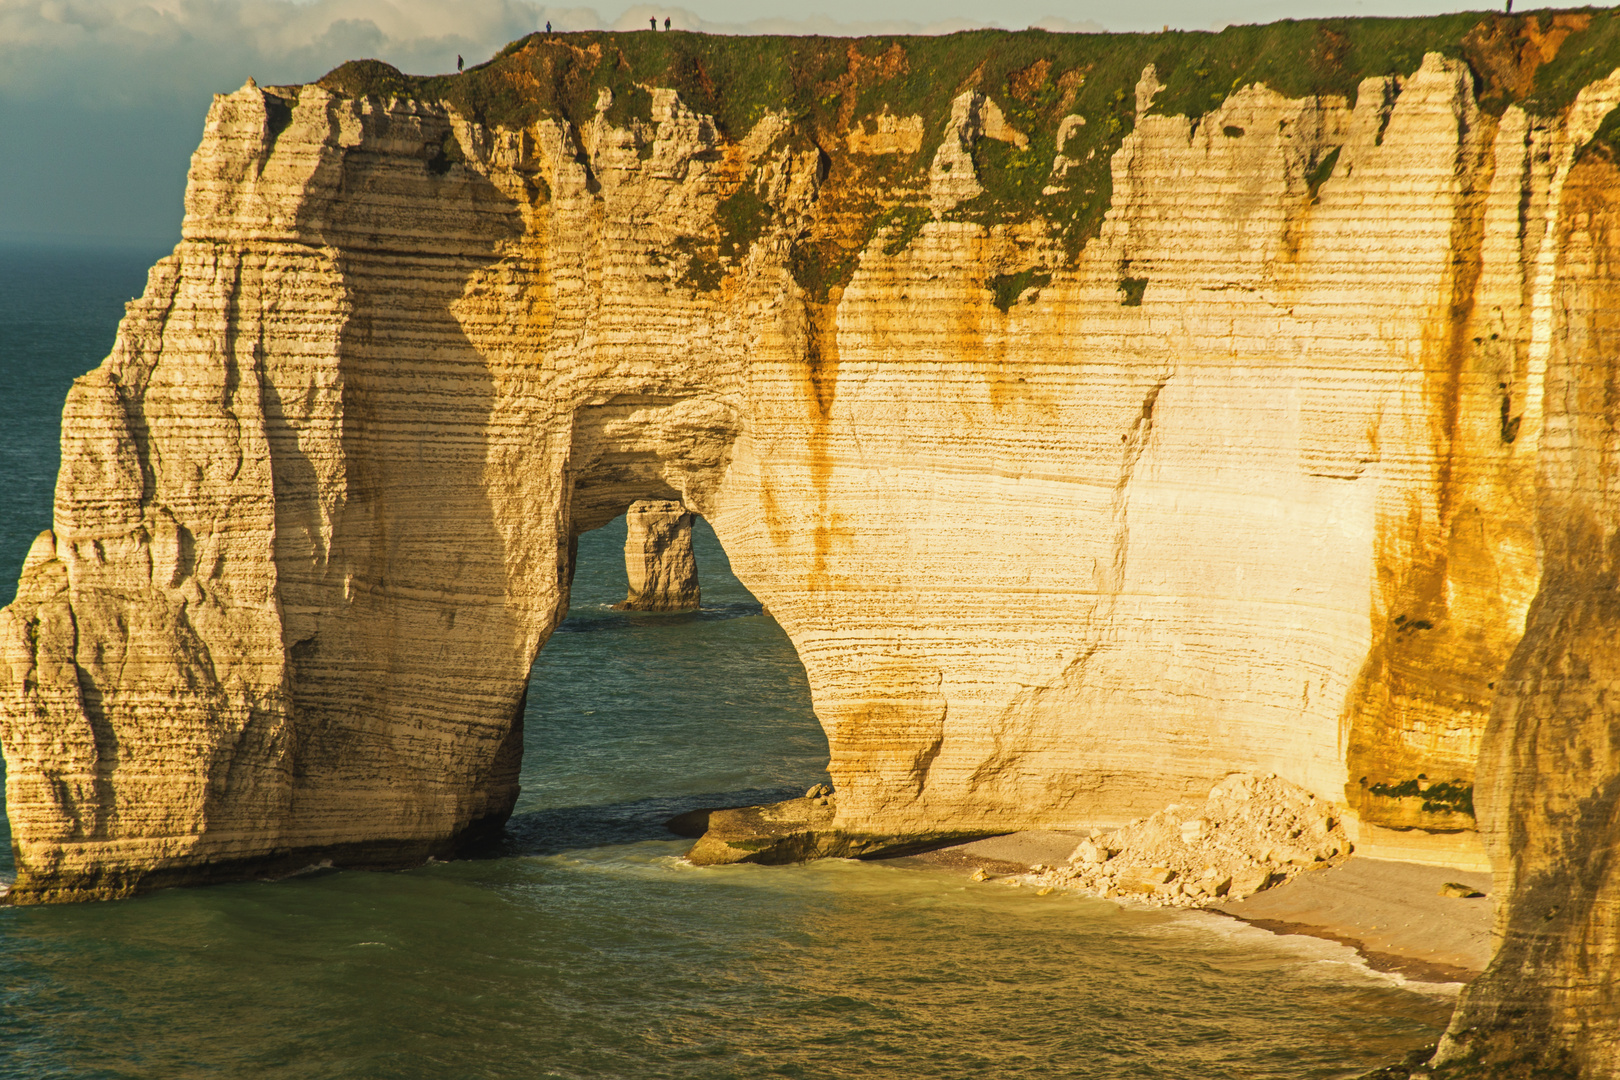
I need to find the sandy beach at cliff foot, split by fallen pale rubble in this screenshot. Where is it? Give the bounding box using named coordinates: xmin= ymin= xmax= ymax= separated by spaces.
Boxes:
xmin=902 ymin=831 xmax=1492 ymax=983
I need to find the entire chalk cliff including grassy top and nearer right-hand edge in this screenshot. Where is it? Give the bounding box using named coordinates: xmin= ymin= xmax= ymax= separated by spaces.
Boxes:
xmin=0 ymin=15 xmax=1620 ymax=1075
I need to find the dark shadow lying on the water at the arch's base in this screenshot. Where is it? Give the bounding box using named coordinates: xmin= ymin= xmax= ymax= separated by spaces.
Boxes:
xmin=460 ymin=787 xmax=804 ymax=858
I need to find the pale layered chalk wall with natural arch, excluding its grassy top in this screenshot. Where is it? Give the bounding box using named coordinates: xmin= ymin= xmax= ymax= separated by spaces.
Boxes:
xmin=5 ymin=57 xmax=1609 ymax=899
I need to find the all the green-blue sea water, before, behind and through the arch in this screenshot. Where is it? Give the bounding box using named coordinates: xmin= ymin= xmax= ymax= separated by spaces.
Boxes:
xmin=0 ymin=249 xmax=1450 ymax=1080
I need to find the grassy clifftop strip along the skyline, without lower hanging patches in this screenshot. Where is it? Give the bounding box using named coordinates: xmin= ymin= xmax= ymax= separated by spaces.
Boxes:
xmin=321 ymin=8 xmax=1620 ymax=128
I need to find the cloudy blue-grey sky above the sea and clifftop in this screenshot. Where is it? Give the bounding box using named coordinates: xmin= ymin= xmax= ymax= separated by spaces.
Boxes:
xmin=0 ymin=0 xmax=1494 ymax=248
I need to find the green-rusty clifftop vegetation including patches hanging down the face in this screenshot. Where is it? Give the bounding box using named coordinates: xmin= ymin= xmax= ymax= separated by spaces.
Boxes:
xmin=321 ymin=8 xmax=1620 ymax=278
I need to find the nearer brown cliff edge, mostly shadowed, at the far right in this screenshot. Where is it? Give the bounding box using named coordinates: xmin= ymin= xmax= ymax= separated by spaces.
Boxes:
xmin=1440 ymin=139 xmax=1620 ymax=1077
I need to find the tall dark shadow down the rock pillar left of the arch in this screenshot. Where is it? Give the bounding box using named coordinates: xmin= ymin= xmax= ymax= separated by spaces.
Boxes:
xmin=249 ymin=100 xmax=538 ymax=863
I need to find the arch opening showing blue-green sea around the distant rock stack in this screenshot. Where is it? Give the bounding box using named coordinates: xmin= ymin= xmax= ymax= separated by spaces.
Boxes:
xmin=502 ymin=507 xmax=828 ymax=855
